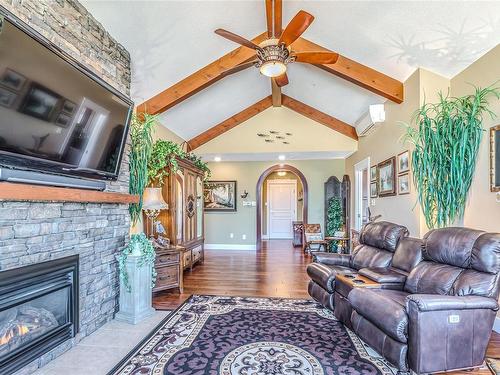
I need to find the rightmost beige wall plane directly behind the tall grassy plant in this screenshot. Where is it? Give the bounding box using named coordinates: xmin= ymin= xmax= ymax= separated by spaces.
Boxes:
xmin=451 ymin=46 xmax=500 ymax=232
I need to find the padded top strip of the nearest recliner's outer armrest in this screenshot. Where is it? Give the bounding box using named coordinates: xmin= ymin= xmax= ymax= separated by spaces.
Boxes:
xmin=406 ymin=294 xmax=498 ymax=312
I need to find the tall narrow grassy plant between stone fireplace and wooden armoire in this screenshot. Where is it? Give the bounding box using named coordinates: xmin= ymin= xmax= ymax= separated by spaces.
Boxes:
xmin=129 ymin=113 xmax=157 ymax=225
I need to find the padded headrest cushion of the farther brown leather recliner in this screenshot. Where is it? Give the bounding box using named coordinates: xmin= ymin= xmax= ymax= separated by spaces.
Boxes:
xmin=359 ymin=221 xmax=408 ymax=252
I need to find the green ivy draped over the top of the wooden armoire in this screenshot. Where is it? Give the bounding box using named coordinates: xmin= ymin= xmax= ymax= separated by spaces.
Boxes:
xmin=148 ymin=140 xmax=210 ymax=186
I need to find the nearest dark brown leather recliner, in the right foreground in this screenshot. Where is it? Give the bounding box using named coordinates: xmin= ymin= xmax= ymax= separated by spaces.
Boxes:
xmin=348 ymin=228 xmax=500 ymax=374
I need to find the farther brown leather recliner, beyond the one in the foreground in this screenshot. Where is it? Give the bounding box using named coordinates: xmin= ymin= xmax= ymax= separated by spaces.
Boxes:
xmin=307 ymin=221 xmax=408 ymax=310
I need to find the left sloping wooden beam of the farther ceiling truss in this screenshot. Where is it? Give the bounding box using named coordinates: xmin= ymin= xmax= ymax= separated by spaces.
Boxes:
xmin=188 ymin=95 xmax=273 ymax=151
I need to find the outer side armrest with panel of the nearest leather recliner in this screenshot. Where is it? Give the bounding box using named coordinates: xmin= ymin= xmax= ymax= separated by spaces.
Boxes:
xmin=406 ymin=294 xmax=498 ymax=374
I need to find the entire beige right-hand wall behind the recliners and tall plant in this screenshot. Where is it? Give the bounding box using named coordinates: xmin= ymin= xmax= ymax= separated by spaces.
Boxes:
xmin=346 ymin=46 xmax=500 ymax=237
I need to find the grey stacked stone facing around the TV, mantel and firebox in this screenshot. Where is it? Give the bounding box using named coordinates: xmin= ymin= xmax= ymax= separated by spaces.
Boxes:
xmin=0 ymin=0 xmax=130 ymax=373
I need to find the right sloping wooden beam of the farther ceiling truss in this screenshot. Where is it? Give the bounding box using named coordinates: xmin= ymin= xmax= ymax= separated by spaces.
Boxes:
xmin=281 ymin=94 xmax=358 ymax=140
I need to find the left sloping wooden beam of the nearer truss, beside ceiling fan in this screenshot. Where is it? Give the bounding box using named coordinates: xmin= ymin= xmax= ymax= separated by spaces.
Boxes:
xmin=137 ymin=33 xmax=267 ymax=115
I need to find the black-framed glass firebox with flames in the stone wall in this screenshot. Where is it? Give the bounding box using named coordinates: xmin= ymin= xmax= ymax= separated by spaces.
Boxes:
xmin=0 ymin=255 xmax=78 ymax=375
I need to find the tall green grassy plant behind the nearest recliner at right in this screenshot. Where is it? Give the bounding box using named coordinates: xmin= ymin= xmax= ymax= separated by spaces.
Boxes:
xmin=404 ymin=86 xmax=500 ymax=228
